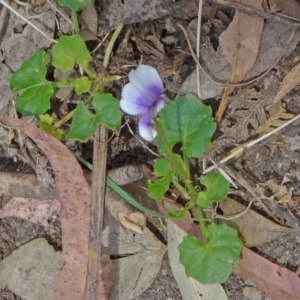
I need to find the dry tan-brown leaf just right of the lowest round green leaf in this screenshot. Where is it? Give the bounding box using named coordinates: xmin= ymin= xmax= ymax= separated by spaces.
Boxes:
xmin=219 ymin=197 xmax=294 ymax=247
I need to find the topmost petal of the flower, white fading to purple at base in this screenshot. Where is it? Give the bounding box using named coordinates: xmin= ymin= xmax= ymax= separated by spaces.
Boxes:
xmin=128 ymin=65 xmax=164 ymax=101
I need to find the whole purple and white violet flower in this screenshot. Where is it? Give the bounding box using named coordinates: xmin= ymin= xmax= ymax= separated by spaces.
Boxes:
xmin=120 ymin=65 xmax=165 ymax=141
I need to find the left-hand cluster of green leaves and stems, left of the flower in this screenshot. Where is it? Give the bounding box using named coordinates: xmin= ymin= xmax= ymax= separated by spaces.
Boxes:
xmin=10 ymin=0 xmax=122 ymax=142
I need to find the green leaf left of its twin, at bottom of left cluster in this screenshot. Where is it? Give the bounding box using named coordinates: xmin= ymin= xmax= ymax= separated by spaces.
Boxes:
xmin=68 ymin=103 xmax=97 ymax=142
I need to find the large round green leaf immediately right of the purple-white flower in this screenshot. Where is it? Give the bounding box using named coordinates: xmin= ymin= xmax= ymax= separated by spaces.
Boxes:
xmin=157 ymin=94 xmax=216 ymax=157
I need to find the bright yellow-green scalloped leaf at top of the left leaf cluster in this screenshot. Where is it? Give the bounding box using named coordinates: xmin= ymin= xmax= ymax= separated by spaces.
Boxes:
xmin=52 ymin=34 xmax=92 ymax=72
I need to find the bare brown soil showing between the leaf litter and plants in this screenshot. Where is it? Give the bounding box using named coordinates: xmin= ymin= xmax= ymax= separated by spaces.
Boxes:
xmin=0 ymin=0 xmax=300 ymax=300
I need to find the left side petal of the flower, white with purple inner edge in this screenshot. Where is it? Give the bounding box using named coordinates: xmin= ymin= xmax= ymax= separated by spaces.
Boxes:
xmin=120 ymin=82 xmax=153 ymax=115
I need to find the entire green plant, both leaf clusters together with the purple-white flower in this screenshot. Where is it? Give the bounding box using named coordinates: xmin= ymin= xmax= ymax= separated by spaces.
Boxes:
xmin=10 ymin=0 xmax=243 ymax=284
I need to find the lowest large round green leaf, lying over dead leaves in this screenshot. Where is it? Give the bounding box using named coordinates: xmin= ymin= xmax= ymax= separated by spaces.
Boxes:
xmin=178 ymin=223 xmax=243 ymax=284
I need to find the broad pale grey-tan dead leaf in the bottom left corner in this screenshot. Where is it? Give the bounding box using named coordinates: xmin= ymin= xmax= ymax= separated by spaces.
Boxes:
xmin=0 ymin=239 xmax=63 ymax=300
